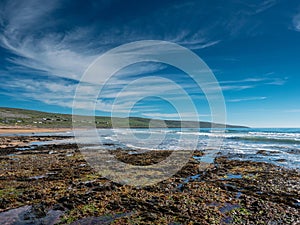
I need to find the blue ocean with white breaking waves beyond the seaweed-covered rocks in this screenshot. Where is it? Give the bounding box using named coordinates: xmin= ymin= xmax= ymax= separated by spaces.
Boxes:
xmin=87 ymin=128 xmax=300 ymax=169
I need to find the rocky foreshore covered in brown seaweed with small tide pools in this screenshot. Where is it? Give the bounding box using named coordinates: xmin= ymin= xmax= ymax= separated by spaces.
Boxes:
xmin=0 ymin=136 xmax=300 ymax=225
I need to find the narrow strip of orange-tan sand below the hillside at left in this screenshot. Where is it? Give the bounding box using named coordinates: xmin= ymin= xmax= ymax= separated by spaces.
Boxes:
xmin=0 ymin=127 xmax=72 ymax=134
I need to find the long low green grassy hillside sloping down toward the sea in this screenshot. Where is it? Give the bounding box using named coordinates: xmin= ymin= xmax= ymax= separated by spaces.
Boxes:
xmin=0 ymin=107 xmax=245 ymax=128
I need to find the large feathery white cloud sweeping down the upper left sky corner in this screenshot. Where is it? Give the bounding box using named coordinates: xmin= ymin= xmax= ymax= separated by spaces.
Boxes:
xmin=0 ymin=0 xmax=95 ymax=79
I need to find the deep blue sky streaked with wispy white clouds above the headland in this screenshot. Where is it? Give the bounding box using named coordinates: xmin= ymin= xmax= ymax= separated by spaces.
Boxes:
xmin=0 ymin=0 xmax=300 ymax=127
